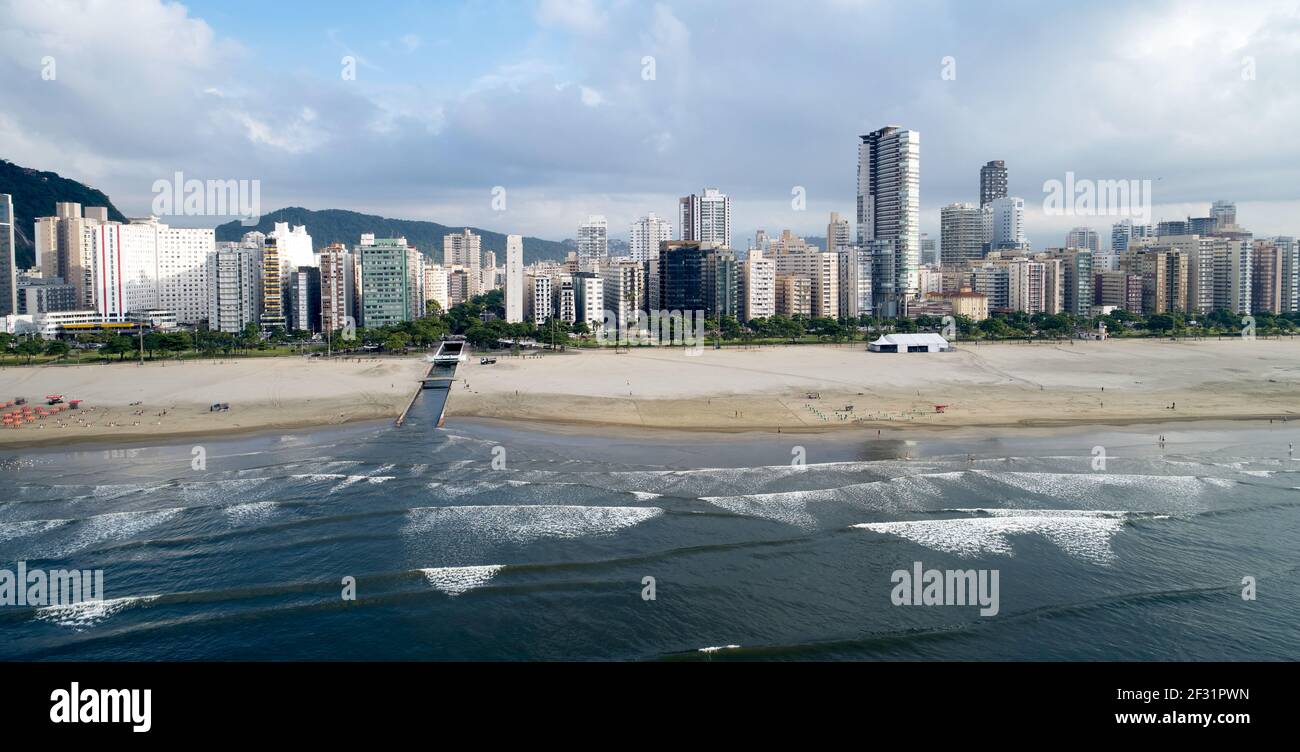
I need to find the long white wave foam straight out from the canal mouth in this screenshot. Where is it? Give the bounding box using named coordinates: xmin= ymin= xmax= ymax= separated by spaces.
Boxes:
xmin=403 ymin=505 xmax=663 ymax=543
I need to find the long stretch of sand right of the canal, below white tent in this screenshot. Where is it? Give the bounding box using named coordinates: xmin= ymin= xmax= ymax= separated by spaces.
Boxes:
xmin=447 ymin=340 xmax=1300 ymax=432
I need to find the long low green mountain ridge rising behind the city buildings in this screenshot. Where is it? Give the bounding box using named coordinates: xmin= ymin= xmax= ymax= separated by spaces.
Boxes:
xmin=217 ymin=207 xmax=569 ymax=264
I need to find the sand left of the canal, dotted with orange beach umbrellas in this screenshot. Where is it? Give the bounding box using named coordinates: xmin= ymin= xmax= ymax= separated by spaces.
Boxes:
xmin=0 ymin=356 xmax=428 ymax=446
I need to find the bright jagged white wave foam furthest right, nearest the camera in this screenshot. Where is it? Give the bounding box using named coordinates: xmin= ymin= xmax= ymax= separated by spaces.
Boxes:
xmin=853 ymin=509 xmax=1125 ymax=565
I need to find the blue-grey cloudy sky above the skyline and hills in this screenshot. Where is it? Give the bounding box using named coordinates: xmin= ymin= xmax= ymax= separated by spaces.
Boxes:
xmin=0 ymin=0 xmax=1300 ymax=247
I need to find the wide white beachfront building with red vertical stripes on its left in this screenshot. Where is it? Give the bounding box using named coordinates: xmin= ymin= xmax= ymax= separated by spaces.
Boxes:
xmin=87 ymin=217 xmax=216 ymax=324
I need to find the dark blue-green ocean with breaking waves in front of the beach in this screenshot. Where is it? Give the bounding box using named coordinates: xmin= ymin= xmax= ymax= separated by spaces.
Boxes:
xmin=0 ymin=392 xmax=1300 ymax=661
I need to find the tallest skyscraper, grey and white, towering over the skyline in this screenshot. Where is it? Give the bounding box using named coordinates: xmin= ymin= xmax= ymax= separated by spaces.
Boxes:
xmin=858 ymin=125 xmax=920 ymax=317
